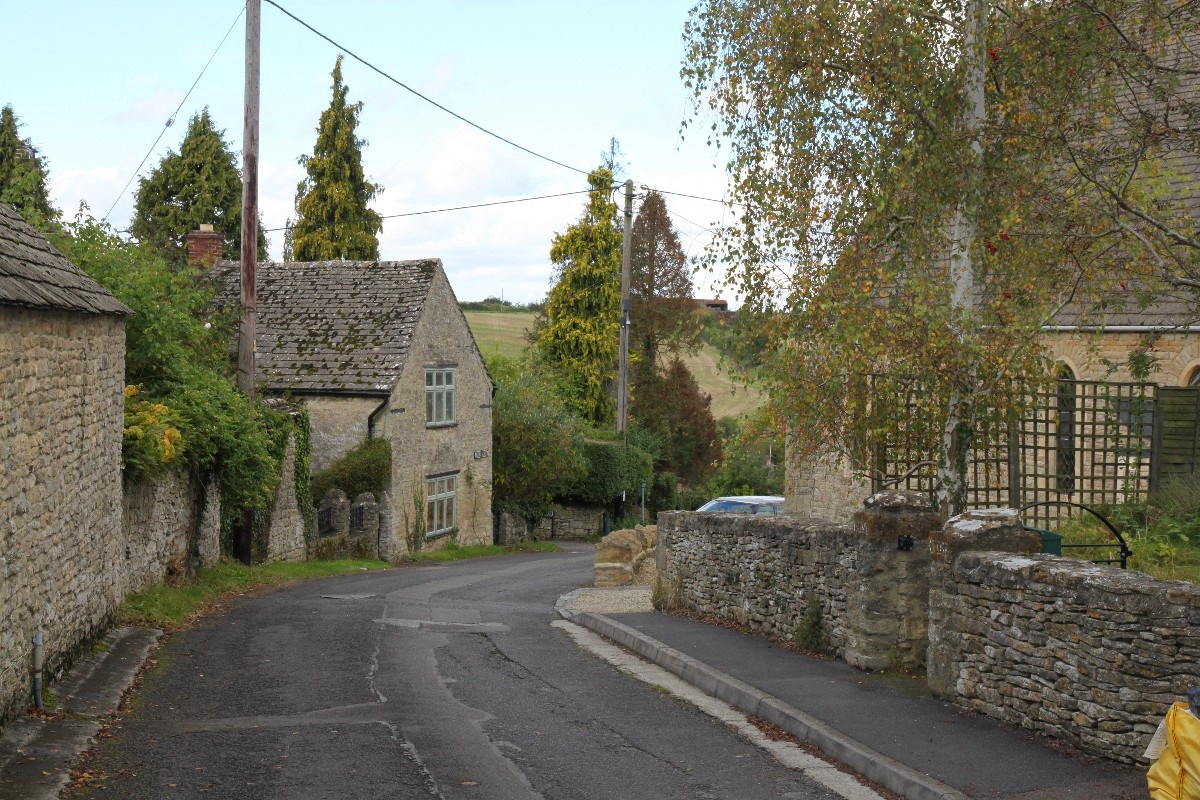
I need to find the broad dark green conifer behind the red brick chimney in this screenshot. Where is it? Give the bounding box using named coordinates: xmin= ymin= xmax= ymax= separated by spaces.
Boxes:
xmin=130 ymin=108 xmax=266 ymax=264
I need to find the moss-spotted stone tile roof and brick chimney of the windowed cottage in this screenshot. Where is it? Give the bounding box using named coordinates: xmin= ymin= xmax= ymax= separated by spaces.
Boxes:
xmin=212 ymin=259 xmax=442 ymax=396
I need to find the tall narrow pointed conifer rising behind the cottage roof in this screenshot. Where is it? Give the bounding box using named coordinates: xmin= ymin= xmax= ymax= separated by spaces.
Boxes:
xmin=284 ymin=54 xmax=383 ymax=261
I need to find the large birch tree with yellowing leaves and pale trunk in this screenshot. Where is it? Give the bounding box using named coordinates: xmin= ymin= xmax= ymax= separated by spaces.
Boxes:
xmin=683 ymin=0 xmax=1192 ymax=513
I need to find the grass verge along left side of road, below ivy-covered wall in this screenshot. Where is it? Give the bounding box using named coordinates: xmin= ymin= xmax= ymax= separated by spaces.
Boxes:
xmin=118 ymin=560 xmax=389 ymax=631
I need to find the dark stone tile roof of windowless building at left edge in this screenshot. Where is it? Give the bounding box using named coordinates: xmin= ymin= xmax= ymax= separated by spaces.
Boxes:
xmin=0 ymin=203 xmax=132 ymax=314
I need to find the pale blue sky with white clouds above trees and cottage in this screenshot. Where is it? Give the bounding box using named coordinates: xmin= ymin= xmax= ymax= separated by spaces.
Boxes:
xmin=0 ymin=0 xmax=726 ymax=301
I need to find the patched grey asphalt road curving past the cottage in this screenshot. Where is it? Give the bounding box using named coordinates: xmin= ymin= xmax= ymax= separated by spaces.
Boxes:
xmin=73 ymin=546 xmax=836 ymax=800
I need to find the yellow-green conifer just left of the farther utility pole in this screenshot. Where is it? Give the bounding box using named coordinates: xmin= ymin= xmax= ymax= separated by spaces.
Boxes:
xmin=538 ymin=167 xmax=622 ymax=423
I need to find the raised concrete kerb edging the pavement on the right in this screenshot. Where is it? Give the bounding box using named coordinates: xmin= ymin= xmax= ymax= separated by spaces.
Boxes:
xmin=556 ymin=604 xmax=970 ymax=800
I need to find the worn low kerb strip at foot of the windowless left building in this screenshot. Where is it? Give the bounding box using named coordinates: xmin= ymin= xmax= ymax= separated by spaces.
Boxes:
xmin=0 ymin=627 xmax=162 ymax=800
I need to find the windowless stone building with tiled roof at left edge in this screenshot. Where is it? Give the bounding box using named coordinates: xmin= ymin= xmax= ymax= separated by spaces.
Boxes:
xmin=0 ymin=203 xmax=130 ymax=718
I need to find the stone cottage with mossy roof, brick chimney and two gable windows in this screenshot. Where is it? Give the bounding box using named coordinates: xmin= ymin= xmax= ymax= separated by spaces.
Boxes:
xmin=214 ymin=259 xmax=494 ymax=559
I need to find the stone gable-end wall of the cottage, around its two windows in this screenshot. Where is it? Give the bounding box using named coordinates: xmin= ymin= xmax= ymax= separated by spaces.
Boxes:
xmin=386 ymin=271 xmax=492 ymax=559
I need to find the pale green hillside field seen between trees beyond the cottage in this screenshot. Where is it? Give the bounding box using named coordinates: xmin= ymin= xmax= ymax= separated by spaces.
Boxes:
xmin=463 ymin=311 xmax=764 ymax=419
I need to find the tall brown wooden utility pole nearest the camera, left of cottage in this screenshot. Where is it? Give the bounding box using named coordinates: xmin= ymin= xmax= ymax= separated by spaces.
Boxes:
xmin=238 ymin=0 xmax=262 ymax=398
